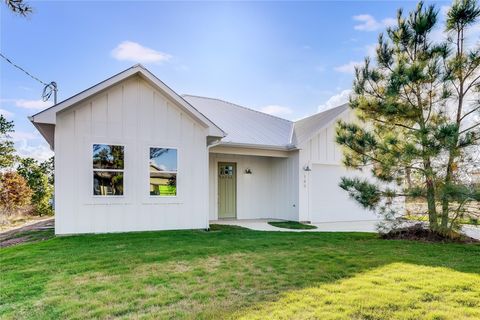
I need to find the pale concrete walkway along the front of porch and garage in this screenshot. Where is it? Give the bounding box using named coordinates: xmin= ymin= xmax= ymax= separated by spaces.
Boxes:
xmin=210 ymin=219 xmax=377 ymax=232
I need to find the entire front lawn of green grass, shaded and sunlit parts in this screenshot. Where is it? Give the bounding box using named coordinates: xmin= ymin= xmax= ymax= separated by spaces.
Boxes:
xmin=0 ymin=227 xmax=480 ymax=320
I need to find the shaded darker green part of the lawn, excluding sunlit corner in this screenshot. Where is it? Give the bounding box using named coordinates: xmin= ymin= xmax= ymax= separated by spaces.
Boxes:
xmin=0 ymin=227 xmax=480 ymax=319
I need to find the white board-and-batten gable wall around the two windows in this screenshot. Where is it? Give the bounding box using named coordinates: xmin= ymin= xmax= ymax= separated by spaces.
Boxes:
xmin=55 ymin=76 xmax=208 ymax=234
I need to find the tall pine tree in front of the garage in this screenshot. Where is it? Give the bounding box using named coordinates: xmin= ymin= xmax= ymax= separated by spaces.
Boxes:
xmin=336 ymin=0 xmax=480 ymax=235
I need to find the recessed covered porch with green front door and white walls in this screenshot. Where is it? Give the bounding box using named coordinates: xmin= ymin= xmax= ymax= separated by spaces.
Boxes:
xmin=209 ymin=145 xmax=299 ymax=221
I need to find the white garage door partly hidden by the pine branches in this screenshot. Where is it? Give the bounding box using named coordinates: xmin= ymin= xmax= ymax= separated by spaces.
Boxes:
xmin=309 ymin=164 xmax=376 ymax=222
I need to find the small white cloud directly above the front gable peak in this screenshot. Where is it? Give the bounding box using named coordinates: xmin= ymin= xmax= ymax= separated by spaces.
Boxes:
xmin=111 ymin=41 xmax=172 ymax=63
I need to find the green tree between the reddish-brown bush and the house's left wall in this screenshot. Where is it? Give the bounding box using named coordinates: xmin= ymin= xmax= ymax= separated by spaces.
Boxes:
xmin=17 ymin=158 xmax=53 ymax=215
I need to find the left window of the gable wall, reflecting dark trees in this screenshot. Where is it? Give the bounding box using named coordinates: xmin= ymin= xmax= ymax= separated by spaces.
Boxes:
xmin=93 ymin=144 xmax=124 ymax=196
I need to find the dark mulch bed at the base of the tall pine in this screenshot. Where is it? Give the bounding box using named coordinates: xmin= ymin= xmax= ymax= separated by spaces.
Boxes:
xmin=381 ymin=223 xmax=480 ymax=243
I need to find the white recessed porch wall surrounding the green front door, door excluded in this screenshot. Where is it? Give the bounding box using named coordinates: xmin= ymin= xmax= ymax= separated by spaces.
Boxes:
xmin=209 ymin=151 xmax=298 ymax=220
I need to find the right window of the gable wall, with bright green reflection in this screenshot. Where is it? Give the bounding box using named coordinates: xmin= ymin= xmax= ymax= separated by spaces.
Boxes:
xmin=149 ymin=148 xmax=177 ymax=196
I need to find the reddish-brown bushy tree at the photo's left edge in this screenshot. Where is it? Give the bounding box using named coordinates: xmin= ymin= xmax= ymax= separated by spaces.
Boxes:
xmin=0 ymin=171 xmax=32 ymax=218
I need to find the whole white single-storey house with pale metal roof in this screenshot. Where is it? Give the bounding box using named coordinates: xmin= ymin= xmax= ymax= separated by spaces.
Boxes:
xmin=30 ymin=65 xmax=375 ymax=234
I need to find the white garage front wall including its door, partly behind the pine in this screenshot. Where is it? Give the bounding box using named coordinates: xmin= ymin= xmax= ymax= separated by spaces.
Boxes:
xmin=298 ymin=110 xmax=377 ymax=222
